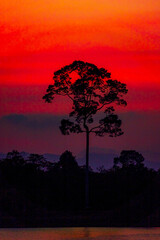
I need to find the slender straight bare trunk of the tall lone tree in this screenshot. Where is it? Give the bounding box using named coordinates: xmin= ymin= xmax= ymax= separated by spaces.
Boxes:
xmin=85 ymin=130 xmax=89 ymax=209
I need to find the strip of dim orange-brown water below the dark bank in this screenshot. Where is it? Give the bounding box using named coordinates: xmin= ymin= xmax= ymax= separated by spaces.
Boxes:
xmin=0 ymin=228 xmax=160 ymax=240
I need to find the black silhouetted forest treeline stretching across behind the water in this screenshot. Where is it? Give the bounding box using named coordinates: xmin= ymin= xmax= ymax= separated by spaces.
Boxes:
xmin=0 ymin=151 xmax=160 ymax=227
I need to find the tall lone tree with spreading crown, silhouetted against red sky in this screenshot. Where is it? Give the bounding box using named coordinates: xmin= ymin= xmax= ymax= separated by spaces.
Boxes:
xmin=43 ymin=61 xmax=127 ymax=208
